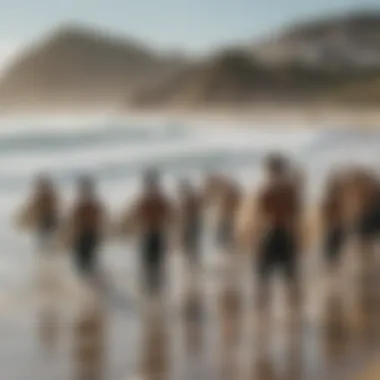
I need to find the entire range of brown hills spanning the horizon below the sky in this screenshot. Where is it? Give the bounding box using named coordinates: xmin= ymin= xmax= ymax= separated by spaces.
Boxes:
xmin=0 ymin=12 xmax=380 ymax=111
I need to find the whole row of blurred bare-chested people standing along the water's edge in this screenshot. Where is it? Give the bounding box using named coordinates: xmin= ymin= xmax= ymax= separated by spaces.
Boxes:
xmin=13 ymin=153 xmax=380 ymax=310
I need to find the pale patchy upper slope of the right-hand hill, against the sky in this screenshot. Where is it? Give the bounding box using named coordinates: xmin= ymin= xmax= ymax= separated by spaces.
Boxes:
xmin=251 ymin=10 xmax=380 ymax=68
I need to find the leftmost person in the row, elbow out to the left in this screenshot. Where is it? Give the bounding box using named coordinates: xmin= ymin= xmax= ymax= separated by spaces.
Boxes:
xmin=16 ymin=175 xmax=59 ymax=250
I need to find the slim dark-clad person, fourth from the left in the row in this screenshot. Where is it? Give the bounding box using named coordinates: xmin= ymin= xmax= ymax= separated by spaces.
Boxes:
xmin=179 ymin=181 xmax=203 ymax=265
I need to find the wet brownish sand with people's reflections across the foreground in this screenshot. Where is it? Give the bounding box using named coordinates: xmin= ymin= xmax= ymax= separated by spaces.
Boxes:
xmin=0 ymin=239 xmax=380 ymax=380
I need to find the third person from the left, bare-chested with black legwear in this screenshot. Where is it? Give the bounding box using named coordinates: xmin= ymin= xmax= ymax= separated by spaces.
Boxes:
xmin=122 ymin=169 xmax=174 ymax=295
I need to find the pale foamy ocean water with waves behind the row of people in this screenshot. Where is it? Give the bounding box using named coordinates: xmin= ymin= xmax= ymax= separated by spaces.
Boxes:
xmin=0 ymin=118 xmax=380 ymax=379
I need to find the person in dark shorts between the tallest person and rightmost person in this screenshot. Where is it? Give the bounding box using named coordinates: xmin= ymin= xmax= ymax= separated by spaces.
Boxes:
xmin=320 ymin=173 xmax=346 ymax=269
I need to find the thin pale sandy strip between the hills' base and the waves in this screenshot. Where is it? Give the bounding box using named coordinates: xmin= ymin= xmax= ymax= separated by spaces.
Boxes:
xmin=0 ymin=105 xmax=380 ymax=130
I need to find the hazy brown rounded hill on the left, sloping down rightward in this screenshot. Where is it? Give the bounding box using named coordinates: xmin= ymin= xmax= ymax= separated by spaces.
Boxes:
xmin=0 ymin=25 xmax=183 ymax=107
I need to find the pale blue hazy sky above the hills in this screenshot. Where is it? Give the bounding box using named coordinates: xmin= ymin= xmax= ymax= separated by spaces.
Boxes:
xmin=0 ymin=0 xmax=380 ymax=59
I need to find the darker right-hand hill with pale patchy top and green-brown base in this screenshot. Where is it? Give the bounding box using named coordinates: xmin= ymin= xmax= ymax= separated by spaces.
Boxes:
xmin=133 ymin=12 xmax=380 ymax=107
